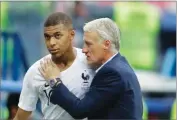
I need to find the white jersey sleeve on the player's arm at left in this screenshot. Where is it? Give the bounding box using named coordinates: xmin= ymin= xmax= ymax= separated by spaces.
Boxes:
xmin=18 ymin=66 xmax=38 ymax=111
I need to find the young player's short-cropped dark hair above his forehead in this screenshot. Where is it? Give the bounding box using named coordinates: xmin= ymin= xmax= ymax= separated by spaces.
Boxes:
xmin=44 ymin=12 xmax=72 ymax=28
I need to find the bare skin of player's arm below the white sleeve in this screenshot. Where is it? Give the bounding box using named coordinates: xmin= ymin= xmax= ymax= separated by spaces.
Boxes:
xmin=13 ymin=108 xmax=32 ymax=120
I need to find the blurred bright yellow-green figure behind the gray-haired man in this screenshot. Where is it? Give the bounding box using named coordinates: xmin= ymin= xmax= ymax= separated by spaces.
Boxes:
xmin=113 ymin=2 xmax=160 ymax=70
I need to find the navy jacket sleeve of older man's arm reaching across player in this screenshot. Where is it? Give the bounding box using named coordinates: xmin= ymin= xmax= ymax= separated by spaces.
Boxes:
xmin=50 ymin=71 xmax=124 ymax=119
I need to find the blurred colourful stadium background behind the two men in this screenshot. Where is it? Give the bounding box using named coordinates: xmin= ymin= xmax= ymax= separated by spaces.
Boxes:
xmin=0 ymin=1 xmax=176 ymax=120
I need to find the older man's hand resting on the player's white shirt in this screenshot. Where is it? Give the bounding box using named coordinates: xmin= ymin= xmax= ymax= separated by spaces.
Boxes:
xmin=39 ymin=58 xmax=60 ymax=80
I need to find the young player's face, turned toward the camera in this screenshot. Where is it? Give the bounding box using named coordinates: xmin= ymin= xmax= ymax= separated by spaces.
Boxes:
xmin=44 ymin=24 xmax=74 ymax=57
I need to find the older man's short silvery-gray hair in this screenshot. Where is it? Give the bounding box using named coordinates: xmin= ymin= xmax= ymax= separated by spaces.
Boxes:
xmin=83 ymin=18 xmax=120 ymax=52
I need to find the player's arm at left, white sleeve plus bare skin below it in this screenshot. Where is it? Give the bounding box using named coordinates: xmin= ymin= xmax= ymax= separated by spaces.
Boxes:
xmin=14 ymin=68 xmax=38 ymax=120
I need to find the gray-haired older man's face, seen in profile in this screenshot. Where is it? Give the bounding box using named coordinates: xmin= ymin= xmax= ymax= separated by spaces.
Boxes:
xmin=82 ymin=32 xmax=104 ymax=66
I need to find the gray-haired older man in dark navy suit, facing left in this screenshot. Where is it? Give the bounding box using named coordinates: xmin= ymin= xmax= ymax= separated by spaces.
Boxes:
xmin=41 ymin=18 xmax=143 ymax=120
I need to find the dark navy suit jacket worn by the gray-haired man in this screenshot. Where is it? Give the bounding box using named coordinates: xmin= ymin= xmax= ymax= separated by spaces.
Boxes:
xmin=50 ymin=53 xmax=143 ymax=120
